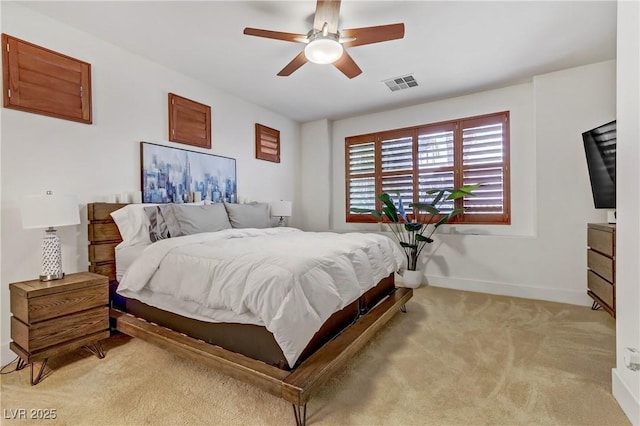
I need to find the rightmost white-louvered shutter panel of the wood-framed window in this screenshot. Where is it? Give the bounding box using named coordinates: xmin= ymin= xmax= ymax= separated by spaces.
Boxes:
xmin=462 ymin=113 xmax=509 ymax=222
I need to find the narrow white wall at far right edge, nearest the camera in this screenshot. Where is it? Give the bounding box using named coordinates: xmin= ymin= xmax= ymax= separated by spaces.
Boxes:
xmin=612 ymin=1 xmax=640 ymax=425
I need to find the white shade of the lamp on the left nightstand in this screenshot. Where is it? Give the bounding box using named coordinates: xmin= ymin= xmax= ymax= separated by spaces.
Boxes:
xmin=20 ymin=194 xmax=80 ymax=229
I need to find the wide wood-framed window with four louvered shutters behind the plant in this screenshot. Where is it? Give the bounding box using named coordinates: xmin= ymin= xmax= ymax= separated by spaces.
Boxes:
xmin=345 ymin=111 xmax=511 ymax=224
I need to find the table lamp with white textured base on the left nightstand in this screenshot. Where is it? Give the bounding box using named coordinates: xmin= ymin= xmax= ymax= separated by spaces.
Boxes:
xmin=20 ymin=191 xmax=80 ymax=281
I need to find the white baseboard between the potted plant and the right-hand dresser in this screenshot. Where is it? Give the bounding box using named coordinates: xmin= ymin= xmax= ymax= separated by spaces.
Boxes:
xmin=427 ymin=275 xmax=593 ymax=306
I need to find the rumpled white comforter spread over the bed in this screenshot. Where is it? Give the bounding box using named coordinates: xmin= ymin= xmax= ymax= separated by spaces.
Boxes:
xmin=118 ymin=228 xmax=404 ymax=366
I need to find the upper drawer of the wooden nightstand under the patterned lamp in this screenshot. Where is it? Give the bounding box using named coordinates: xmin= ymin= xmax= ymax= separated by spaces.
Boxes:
xmin=11 ymin=285 xmax=109 ymax=324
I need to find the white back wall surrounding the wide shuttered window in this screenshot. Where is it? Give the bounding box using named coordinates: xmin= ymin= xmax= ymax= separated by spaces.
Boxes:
xmin=303 ymin=61 xmax=616 ymax=305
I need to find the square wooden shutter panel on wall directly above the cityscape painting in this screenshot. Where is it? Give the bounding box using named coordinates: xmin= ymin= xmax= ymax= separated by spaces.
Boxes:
xmin=169 ymin=93 xmax=211 ymax=148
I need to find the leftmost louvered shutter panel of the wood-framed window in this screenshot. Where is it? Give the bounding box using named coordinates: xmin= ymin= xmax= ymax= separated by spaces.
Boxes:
xmin=346 ymin=137 xmax=376 ymax=221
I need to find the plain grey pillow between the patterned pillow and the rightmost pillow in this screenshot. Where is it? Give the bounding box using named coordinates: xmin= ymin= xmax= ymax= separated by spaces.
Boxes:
xmin=162 ymin=203 xmax=231 ymax=237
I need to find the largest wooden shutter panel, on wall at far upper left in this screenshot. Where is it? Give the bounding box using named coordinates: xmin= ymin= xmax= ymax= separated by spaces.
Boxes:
xmin=2 ymin=34 xmax=92 ymax=124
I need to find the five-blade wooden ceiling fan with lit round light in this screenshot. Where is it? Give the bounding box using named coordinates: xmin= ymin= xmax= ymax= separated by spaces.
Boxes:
xmin=244 ymin=0 xmax=404 ymax=78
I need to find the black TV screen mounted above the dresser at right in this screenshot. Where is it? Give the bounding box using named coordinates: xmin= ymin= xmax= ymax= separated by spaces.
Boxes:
xmin=582 ymin=120 xmax=616 ymax=209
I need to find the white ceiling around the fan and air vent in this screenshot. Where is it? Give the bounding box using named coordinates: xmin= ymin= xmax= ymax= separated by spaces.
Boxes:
xmin=22 ymin=0 xmax=616 ymax=122
